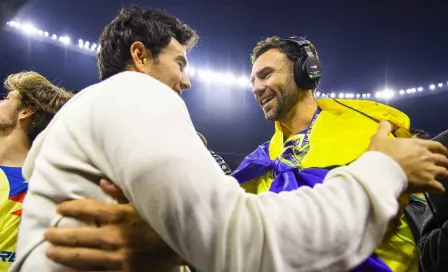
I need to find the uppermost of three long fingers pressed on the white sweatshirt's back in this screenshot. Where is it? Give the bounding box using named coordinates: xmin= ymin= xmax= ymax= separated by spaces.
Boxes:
xmin=57 ymin=199 xmax=133 ymax=224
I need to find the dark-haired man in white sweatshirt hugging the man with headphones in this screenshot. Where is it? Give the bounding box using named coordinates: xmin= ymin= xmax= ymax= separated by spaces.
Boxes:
xmin=11 ymin=8 xmax=448 ymax=271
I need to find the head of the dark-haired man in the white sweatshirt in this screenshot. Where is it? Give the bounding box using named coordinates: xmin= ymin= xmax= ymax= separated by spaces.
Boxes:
xmin=98 ymin=7 xmax=198 ymax=85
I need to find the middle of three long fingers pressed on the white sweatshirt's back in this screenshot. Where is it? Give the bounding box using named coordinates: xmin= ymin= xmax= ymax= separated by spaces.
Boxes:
xmin=45 ymin=226 xmax=126 ymax=249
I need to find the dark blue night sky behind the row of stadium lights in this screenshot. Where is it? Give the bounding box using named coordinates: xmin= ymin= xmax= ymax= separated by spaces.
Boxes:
xmin=0 ymin=0 xmax=448 ymax=168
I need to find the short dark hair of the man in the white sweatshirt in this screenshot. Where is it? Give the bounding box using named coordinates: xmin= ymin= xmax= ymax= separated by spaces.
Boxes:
xmin=98 ymin=6 xmax=199 ymax=80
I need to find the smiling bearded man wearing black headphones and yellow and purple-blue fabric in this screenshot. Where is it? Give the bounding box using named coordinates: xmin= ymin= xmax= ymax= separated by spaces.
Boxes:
xmin=233 ymin=37 xmax=424 ymax=272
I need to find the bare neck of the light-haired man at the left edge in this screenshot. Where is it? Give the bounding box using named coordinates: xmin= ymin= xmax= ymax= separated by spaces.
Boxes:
xmin=0 ymin=131 xmax=31 ymax=167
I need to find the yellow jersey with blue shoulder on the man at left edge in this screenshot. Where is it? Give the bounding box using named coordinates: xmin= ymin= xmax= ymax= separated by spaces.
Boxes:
xmin=0 ymin=166 xmax=28 ymax=272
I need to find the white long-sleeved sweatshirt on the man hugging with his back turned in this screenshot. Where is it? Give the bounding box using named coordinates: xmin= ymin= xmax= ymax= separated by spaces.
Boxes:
xmin=11 ymin=72 xmax=407 ymax=272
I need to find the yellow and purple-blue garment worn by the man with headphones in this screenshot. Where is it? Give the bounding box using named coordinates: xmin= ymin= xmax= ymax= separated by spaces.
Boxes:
xmin=233 ymin=99 xmax=418 ymax=272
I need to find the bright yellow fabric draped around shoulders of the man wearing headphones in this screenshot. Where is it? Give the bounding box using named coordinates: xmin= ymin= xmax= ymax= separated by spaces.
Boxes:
xmin=250 ymin=99 xmax=411 ymax=194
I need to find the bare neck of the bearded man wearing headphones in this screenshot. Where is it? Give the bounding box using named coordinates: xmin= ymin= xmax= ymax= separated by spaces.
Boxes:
xmin=279 ymin=95 xmax=317 ymax=139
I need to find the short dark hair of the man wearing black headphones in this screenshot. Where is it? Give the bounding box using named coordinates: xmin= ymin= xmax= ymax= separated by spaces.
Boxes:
xmin=251 ymin=36 xmax=319 ymax=64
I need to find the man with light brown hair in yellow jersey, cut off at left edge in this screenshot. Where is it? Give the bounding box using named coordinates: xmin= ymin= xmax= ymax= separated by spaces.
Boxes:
xmin=0 ymin=72 xmax=72 ymax=272
